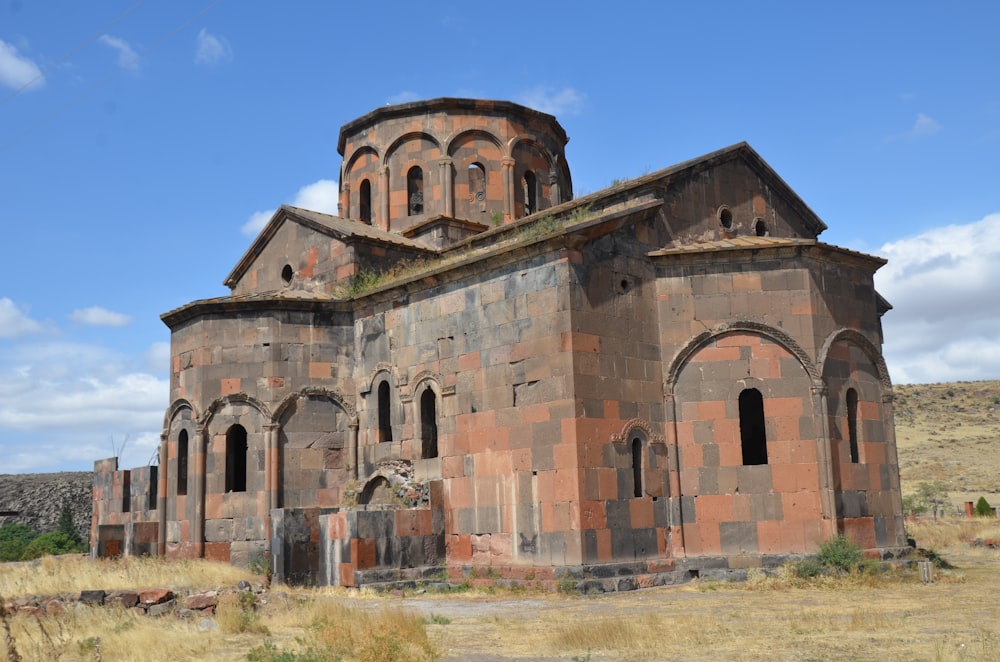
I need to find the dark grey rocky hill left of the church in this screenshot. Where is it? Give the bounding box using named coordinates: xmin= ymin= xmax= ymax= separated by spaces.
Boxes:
xmin=0 ymin=471 xmax=94 ymax=540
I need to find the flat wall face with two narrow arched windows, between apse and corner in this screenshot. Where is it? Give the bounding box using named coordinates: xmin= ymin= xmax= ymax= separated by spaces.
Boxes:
xmin=357 ymin=249 xmax=580 ymax=566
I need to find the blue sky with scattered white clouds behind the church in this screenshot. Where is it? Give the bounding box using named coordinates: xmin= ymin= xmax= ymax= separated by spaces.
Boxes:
xmin=0 ymin=0 xmax=1000 ymax=473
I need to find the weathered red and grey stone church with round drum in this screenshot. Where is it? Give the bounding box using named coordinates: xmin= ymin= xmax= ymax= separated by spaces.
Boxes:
xmin=91 ymin=98 xmax=906 ymax=590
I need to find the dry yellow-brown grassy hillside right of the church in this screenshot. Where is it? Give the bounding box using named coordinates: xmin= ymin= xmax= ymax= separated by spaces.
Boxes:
xmin=893 ymin=381 xmax=1000 ymax=506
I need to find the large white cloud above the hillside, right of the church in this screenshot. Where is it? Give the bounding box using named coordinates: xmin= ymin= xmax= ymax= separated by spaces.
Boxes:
xmin=875 ymin=213 xmax=1000 ymax=383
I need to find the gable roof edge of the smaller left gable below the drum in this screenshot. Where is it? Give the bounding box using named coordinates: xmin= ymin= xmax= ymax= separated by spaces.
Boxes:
xmin=222 ymin=205 xmax=434 ymax=287
